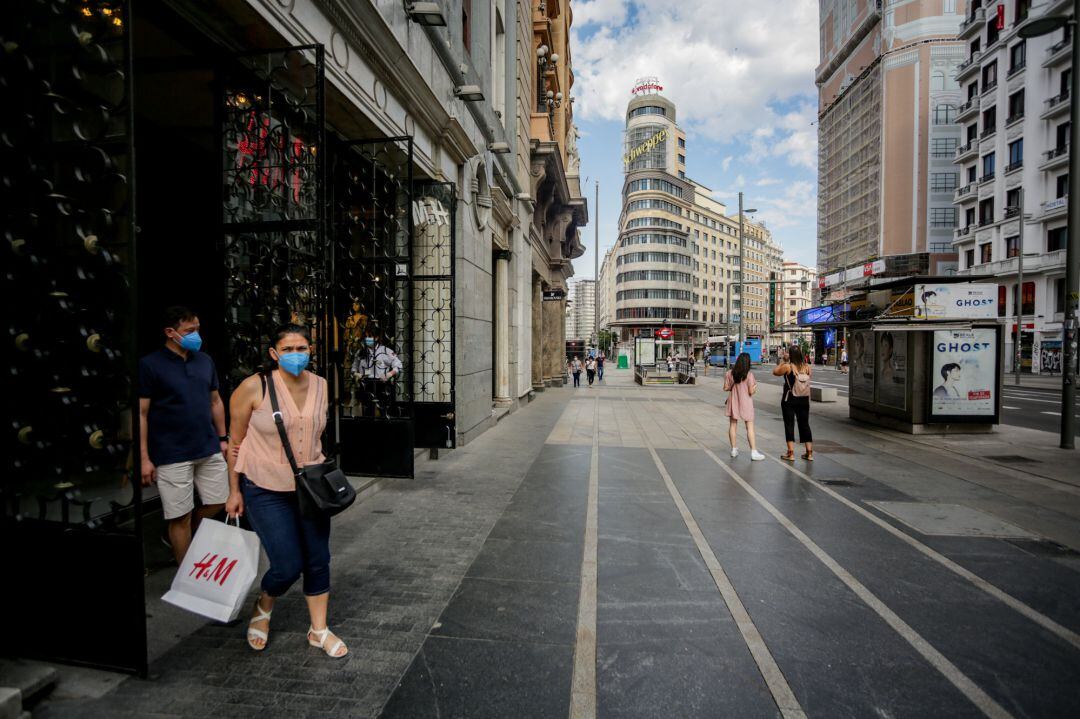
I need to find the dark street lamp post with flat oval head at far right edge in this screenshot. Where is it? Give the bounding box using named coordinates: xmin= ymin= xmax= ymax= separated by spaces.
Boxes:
xmin=1017 ymin=8 xmax=1080 ymax=449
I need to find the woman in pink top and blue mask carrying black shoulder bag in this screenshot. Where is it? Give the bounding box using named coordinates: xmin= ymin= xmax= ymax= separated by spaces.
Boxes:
xmin=225 ymin=325 xmax=349 ymax=659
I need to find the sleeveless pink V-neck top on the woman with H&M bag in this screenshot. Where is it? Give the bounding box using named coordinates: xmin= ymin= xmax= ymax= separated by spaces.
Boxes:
xmin=237 ymin=371 xmax=326 ymax=492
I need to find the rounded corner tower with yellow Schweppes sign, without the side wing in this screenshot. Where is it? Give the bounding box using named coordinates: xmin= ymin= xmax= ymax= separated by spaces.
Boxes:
xmin=611 ymin=94 xmax=705 ymax=351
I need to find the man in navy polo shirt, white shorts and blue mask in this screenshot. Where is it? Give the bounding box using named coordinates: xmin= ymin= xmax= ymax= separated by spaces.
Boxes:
xmin=138 ymin=307 xmax=229 ymax=564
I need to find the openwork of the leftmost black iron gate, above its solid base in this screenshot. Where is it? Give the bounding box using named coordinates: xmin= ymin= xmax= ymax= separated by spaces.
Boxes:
xmin=0 ymin=2 xmax=139 ymax=527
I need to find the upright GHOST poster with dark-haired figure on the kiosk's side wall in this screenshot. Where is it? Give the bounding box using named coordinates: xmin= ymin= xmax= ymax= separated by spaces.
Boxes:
xmin=930 ymin=327 xmax=997 ymax=418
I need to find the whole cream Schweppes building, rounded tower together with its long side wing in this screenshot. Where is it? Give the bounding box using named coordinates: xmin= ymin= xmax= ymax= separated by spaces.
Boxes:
xmin=605 ymin=78 xmax=781 ymax=352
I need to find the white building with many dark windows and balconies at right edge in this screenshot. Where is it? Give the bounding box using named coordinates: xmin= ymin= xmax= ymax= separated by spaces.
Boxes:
xmin=955 ymin=0 xmax=1072 ymax=374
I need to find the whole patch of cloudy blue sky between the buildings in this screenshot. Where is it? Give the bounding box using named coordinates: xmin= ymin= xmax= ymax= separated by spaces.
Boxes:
xmin=570 ymin=0 xmax=818 ymax=277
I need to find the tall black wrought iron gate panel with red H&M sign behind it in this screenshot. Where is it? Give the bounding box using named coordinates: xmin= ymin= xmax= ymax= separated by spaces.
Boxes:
xmin=218 ymin=45 xmax=328 ymax=385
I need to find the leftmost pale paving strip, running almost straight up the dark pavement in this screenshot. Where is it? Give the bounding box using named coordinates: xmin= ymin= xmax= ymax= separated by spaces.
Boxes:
xmin=570 ymin=397 xmax=600 ymax=719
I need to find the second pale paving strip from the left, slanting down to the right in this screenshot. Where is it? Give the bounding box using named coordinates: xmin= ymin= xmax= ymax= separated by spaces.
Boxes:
xmin=623 ymin=401 xmax=806 ymax=719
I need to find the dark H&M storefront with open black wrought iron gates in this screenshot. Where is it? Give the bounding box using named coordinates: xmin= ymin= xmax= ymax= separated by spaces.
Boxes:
xmin=0 ymin=1 xmax=459 ymax=673
